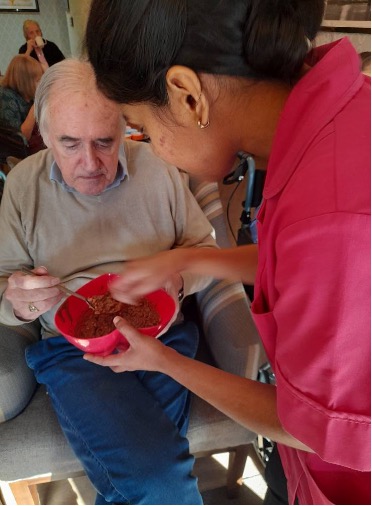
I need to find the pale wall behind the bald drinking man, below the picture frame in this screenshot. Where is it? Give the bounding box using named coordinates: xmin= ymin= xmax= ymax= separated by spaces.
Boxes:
xmin=0 ymin=0 xmax=71 ymax=74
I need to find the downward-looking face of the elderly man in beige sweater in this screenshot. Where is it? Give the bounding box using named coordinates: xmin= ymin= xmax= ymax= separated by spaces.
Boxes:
xmin=45 ymin=93 xmax=122 ymax=195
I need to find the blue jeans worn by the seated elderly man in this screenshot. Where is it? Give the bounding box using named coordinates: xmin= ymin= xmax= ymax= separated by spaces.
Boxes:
xmin=26 ymin=323 xmax=202 ymax=504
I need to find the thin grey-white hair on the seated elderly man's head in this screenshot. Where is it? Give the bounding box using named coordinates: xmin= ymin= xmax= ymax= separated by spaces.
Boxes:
xmin=35 ymin=58 xmax=122 ymax=145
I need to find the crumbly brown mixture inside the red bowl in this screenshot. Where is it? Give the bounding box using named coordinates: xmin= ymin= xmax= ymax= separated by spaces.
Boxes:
xmin=75 ymin=293 xmax=160 ymax=339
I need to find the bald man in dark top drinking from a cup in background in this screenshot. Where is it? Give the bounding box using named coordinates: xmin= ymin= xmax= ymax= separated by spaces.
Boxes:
xmin=18 ymin=19 xmax=65 ymax=70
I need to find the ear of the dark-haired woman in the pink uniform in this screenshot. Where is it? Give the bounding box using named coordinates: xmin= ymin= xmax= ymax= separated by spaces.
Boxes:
xmin=166 ymin=65 xmax=209 ymax=125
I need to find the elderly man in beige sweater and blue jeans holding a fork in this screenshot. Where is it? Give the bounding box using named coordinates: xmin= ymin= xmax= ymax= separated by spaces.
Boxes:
xmin=0 ymin=60 xmax=216 ymax=504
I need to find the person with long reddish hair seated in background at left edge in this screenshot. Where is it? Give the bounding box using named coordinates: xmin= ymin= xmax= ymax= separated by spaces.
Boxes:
xmin=0 ymin=55 xmax=45 ymax=154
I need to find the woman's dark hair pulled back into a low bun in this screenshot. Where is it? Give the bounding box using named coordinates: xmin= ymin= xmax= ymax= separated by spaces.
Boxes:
xmin=85 ymin=0 xmax=324 ymax=105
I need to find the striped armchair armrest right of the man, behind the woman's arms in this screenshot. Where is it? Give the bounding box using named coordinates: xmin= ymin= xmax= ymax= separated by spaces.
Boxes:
xmin=189 ymin=178 xmax=262 ymax=379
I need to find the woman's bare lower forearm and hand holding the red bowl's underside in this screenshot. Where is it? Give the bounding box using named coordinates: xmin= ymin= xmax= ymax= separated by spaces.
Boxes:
xmin=84 ymin=318 xmax=311 ymax=451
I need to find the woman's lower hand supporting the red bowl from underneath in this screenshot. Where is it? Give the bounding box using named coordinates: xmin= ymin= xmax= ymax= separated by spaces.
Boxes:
xmin=84 ymin=316 xmax=174 ymax=372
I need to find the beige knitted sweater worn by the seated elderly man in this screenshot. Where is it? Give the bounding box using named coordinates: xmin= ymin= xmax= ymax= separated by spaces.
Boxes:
xmin=0 ymin=141 xmax=216 ymax=337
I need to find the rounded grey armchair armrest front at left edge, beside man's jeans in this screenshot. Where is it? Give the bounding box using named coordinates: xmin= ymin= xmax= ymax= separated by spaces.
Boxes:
xmin=0 ymin=323 xmax=40 ymax=423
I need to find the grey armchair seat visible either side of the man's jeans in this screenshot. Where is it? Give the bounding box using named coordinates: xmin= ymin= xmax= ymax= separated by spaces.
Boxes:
xmin=0 ymin=386 xmax=254 ymax=481
